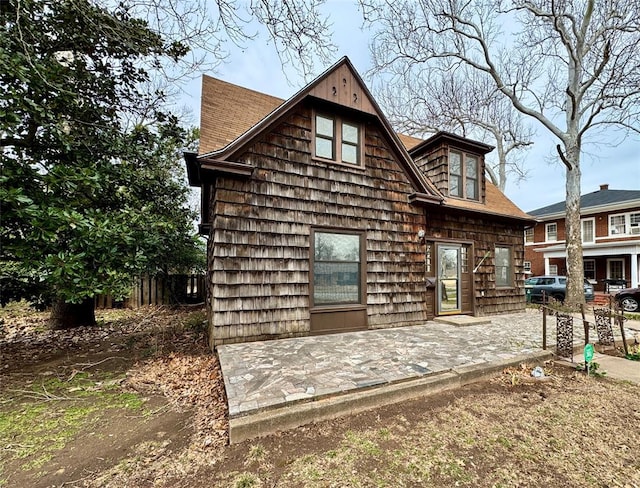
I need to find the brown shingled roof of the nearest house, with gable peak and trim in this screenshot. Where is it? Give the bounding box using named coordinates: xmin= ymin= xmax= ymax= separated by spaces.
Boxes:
xmin=195 ymin=57 xmax=532 ymax=221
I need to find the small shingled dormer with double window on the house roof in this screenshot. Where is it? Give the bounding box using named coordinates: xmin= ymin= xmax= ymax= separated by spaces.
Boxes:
xmin=409 ymin=132 xmax=493 ymax=204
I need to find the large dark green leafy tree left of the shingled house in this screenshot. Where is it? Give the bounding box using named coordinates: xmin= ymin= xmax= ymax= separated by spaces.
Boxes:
xmin=0 ymin=0 xmax=204 ymax=327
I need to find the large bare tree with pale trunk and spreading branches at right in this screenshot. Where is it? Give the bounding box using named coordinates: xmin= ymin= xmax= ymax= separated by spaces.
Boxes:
xmin=360 ymin=0 xmax=640 ymax=303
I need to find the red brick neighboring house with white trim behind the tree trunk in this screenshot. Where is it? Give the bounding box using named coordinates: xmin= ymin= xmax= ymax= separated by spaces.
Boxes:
xmin=525 ymin=185 xmax=640 ymax=291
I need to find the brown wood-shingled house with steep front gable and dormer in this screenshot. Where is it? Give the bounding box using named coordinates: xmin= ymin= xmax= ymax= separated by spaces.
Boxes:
xmin=185 ymin=58 xmax=533 ymax=346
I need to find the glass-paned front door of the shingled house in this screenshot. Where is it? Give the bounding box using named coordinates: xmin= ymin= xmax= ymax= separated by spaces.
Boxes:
xmin=436 ymin=244 xmax=462 ymax=315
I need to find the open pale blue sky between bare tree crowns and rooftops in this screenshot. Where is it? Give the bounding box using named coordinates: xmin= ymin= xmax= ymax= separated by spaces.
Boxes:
xmin=181 ymin=0 xmax=640 ymax=211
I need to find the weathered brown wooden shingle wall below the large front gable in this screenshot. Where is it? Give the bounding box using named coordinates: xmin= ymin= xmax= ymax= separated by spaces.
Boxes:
xmin=209 ymin=107 xmax=427 ymax=345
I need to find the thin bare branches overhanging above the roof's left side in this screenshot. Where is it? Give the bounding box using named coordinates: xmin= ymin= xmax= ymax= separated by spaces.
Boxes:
xmin=128 ymin=0 xmax=336 ymax=81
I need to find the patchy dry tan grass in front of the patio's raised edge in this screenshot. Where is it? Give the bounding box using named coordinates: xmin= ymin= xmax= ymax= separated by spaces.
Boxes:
xmin=214 ymin=370 xmax=640 ymax=488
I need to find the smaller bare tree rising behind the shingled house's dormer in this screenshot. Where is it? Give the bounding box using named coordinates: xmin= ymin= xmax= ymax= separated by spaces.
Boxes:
xmin=374 ymin=66 xmax=534 ymax=191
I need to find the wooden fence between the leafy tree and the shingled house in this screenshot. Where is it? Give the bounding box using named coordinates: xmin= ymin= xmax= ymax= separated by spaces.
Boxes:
xmin=96 ymin=275 xmax=205 ymax=308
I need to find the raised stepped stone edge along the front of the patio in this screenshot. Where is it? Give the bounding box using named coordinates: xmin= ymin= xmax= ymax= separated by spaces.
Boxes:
xmin=229 ymin=350 xmax=554 ymax=444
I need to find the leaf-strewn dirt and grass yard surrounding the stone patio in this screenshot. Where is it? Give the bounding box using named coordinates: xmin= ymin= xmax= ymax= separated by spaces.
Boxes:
xmin=0 ymin=305 xmax=640 ymax=488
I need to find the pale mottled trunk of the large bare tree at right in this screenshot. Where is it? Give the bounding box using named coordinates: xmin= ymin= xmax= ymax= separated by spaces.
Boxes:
xmin=565 ymin=144 xmax=584 ymax=307
